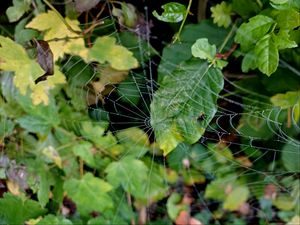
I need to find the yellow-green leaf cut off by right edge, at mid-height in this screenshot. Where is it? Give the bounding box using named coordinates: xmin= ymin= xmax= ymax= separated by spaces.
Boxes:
xmin=270 ymin=91 xmax=300 ymax=123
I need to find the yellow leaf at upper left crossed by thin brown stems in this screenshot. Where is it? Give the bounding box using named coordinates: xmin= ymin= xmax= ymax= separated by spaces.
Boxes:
xmin=26 ymin=11 xmax=88 ymax=61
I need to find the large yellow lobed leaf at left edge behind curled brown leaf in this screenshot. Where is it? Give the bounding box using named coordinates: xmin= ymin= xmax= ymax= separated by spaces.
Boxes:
xmin=0 ymin=36 xmax=65 ymax=105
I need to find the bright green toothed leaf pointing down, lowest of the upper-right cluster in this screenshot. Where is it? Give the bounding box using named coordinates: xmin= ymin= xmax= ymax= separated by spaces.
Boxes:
xmin=254 ymin=34 xmax=279 ymax=76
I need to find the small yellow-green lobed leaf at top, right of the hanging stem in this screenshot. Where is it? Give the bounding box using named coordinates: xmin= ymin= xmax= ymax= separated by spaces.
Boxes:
xmin=210 ymin=2 xmax=232 ymax=28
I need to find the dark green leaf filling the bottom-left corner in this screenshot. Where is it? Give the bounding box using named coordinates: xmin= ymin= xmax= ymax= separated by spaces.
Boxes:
xmin=0 ymin=193 xmax=46 ymax=224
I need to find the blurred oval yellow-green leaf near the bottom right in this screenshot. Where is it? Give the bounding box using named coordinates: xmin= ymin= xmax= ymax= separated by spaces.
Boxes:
xmin=223 ymin=187 xmax=249 ymax=211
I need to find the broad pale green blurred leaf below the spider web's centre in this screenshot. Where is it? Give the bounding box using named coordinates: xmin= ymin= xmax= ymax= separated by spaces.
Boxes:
xmin=105 ymin=157 xmax=148 ymax=198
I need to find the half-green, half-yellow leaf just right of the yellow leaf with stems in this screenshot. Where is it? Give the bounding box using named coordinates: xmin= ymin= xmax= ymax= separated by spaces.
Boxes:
xmin=88 ymin=36 xmax=138 ymax=70
